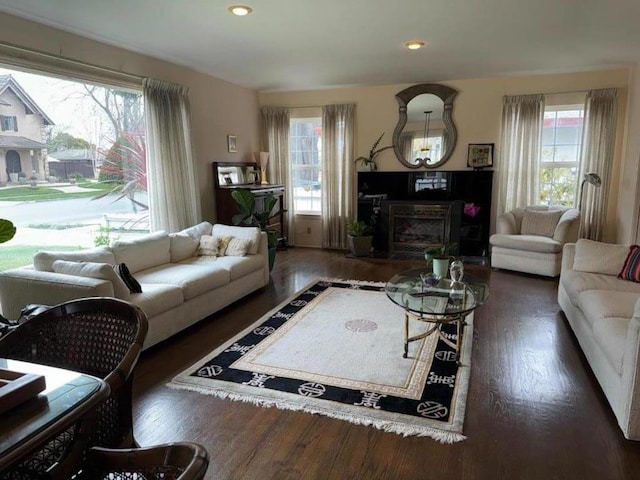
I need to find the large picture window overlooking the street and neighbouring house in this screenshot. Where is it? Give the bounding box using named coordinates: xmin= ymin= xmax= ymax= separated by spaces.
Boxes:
xmin=0 ymin=68 xmax=149 ymax=270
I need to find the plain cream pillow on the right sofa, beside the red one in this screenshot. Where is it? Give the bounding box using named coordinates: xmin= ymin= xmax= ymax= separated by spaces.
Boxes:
xmin=573 ymin=238 xmax=629 ymax=275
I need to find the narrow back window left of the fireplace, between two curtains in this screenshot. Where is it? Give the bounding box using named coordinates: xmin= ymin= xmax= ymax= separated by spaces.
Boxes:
xmin=289 ymin=117 xmax=322 ymax=215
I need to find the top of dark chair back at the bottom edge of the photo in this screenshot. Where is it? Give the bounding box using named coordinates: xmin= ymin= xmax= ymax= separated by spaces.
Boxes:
xmin=74 ymin=442 xmax=209 ymax=480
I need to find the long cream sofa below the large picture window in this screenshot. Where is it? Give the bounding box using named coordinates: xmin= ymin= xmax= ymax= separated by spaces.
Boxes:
xmin=0 ymin=222 xmax=269 ymax=348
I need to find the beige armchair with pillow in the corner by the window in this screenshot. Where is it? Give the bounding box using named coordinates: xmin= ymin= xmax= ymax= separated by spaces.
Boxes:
xmin=489 ymin=205 xmax=580 ymax=277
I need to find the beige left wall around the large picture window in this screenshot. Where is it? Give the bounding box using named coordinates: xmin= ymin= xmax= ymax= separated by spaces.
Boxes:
xmin=0 ymin=13 xmax=258 ymax=221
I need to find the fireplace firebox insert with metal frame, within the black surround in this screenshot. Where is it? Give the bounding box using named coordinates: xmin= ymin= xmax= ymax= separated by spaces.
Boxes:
xmin=381 ymin=201 xmax=462 ymax=259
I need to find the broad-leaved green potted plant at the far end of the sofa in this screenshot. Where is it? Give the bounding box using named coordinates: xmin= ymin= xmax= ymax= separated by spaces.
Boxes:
xmin=231 ymin=188 xmax=280 ymax=271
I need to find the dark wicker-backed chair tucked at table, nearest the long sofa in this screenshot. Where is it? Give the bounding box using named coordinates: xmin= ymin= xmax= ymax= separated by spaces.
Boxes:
xmin=0 ymin=298 xmax=148 ymax=478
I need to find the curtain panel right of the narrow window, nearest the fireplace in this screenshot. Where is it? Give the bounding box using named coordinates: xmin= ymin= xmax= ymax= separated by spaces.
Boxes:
xmin=322 ymin=104 xmax=355 ymax=249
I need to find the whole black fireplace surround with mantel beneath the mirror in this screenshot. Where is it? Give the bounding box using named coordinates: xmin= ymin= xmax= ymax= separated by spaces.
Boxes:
xmin=358 ymin=170 xmax=493 ymax=259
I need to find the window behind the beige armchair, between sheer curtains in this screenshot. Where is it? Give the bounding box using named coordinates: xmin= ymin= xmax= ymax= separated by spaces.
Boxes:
xmin=540 ymin=105 xmax=584 ymax=206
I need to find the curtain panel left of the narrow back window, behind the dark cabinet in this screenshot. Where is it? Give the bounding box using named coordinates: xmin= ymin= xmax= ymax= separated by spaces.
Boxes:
xmin=260 ymin=107 xmax=295 ymax=245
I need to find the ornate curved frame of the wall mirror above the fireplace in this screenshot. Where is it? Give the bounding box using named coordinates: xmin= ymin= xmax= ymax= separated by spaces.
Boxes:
xmin=393 ymin=83 xmax=458 ymax=168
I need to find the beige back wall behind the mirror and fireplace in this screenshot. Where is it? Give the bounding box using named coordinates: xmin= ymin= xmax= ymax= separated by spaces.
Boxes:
xmin=259 ymin=69 xmax=629 ymax=243
